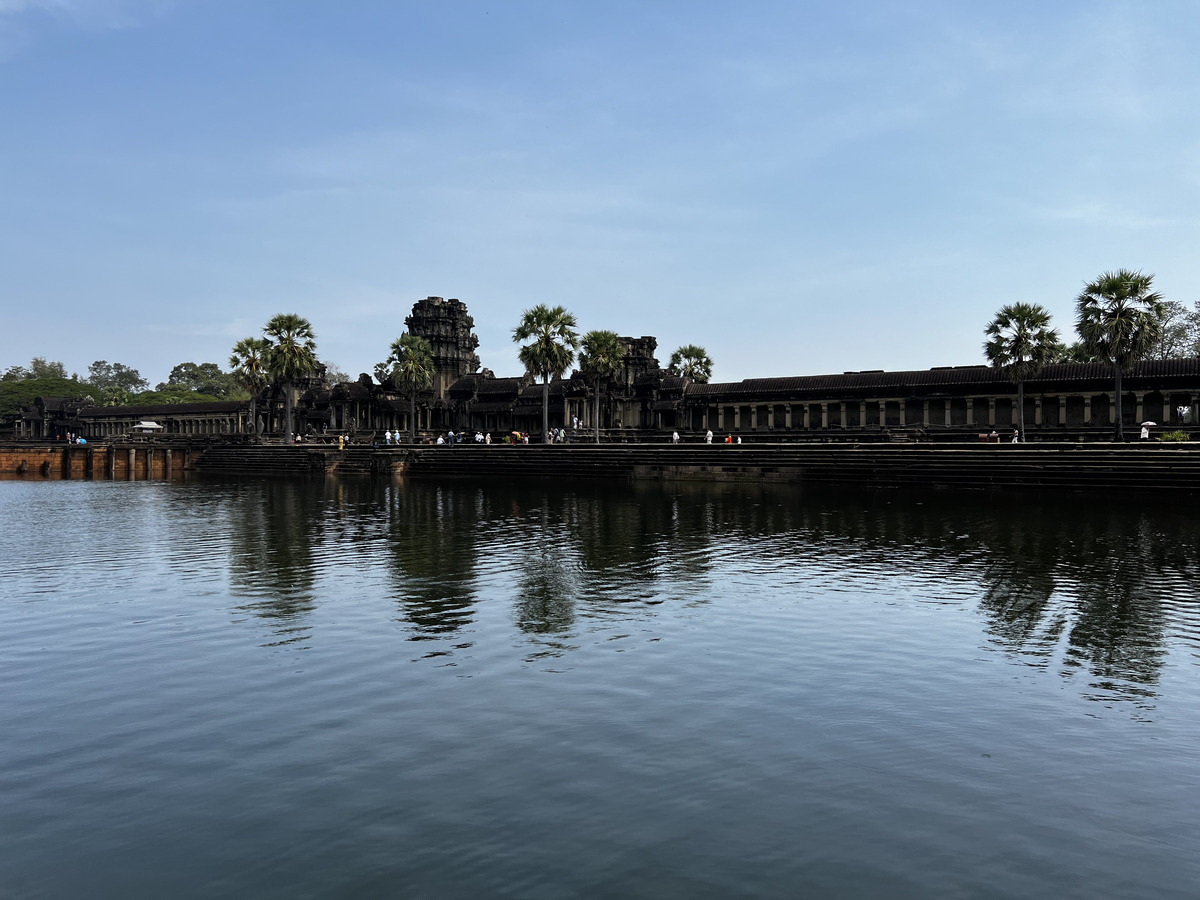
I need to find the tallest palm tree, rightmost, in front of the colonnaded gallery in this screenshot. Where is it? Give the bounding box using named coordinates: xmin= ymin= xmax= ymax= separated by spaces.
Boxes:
xmin=1075 ymin=269 xmax=1165 ymax=440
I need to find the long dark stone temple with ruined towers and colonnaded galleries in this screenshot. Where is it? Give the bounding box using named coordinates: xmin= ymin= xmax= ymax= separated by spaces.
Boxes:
xmin=17 ymin=296 xmax=1200 ymax=442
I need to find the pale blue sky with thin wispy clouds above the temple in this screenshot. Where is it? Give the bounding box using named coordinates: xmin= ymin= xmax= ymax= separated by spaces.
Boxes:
xmin=0 ymin=0 xmax=1200 ymax=382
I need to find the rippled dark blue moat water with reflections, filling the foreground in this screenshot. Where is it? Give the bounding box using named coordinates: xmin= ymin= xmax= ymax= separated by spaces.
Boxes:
xmin=0 ymin=481 xmax=1200 ymax=898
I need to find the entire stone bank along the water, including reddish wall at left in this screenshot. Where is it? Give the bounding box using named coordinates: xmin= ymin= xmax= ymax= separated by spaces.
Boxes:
xmin=0 ymin=438 xmax=1200 ymax=493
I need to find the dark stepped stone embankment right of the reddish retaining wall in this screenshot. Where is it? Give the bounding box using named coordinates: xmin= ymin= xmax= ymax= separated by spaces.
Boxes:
xmin=189 ymin=443 xmax=1200 ymax=492
